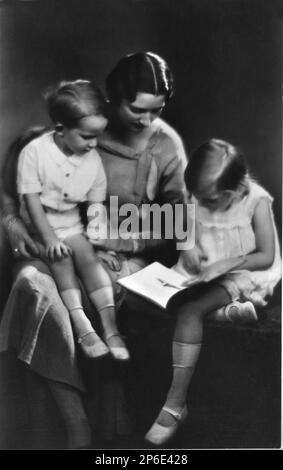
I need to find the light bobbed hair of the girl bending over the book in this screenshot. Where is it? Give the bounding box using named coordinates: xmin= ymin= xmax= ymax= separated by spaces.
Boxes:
xmin=184 ymin=139 xmax=249 ymax=194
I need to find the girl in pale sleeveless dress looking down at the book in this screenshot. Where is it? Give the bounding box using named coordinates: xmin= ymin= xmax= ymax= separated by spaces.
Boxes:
xmin=146 ymin=139 xmax=281 ymax=445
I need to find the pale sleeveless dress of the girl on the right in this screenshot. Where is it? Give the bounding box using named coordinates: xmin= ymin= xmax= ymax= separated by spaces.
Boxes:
xmin=175 ymin=181 xmax=281 ymax=306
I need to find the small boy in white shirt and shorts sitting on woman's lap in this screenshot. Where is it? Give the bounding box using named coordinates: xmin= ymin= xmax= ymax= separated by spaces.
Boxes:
xmin=17 ymin=80 xmax=129 ymax=360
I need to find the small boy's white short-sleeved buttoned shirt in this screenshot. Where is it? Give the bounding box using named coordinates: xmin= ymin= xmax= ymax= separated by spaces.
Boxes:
xmin=17 ymin=132 xmax=107 ymax=208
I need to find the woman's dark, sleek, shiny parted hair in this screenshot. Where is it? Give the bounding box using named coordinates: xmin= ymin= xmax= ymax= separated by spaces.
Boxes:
xmin=106 ymin=52 xmax=173 ymax=105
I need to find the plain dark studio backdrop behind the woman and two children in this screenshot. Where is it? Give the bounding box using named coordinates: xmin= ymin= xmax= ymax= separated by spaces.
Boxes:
xmin=0 ymin=0 xmax=282 ymax=452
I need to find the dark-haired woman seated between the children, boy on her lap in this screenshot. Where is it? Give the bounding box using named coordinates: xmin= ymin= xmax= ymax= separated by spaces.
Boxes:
xmin=0 ymin=52 xmax=190 ymax=448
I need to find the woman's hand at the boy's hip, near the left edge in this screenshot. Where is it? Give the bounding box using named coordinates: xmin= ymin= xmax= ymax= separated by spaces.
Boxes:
xmin=4 ymin=217 xmax=39 ymax=259
